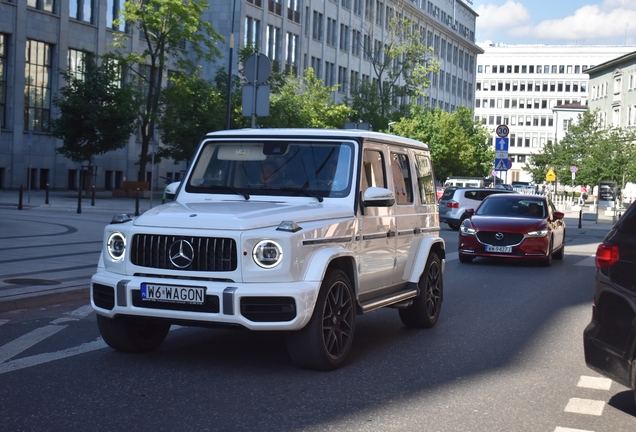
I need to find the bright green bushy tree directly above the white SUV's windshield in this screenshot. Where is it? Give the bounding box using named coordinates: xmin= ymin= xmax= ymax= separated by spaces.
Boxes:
xmin=258 ymin=68 xmax=352 ymax=128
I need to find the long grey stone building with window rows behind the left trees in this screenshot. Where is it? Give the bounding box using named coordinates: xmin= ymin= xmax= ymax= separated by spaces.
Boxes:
xmin=0 ymin=0 xmax=482 ymax=190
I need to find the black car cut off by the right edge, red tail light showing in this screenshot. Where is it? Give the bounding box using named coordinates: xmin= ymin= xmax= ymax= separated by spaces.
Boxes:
xmin=583 ymin=201 xmax=636 ymax=404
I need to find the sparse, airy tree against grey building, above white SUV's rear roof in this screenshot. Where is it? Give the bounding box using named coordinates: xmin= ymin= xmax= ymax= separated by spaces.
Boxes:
xmin=347 ymin=18 xmax=439 ymax=130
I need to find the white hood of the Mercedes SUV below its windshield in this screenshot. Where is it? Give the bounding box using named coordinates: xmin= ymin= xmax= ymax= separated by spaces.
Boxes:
xmin=134 ymin=200 xmax=354 ymax=230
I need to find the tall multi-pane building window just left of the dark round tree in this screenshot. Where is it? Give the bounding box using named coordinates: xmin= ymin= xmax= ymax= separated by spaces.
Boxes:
xmin=24 ymin=39 xmax=53 ymax=132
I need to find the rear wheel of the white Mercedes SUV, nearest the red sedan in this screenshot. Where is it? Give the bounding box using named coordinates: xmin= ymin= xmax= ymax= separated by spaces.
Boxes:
xmin=400 ymin=253 xmax=444 ymax=328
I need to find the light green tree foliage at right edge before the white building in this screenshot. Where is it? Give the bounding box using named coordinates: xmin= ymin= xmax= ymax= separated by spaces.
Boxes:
xmin=524 ymin=110 xmax=636 ymax=186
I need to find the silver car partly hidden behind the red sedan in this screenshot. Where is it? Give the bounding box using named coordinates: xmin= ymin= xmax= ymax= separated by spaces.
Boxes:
xmin=438 ymin=186 xmax=510 ymax=231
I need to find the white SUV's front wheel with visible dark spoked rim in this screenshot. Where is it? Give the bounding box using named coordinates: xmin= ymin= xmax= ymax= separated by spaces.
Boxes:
xmin=287 ymin=270 xmax=356 ymax=371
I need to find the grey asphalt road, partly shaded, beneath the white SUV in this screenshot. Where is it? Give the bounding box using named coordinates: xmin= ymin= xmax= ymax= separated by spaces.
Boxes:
xmin=0 ymin=219 xmax=636 ymax=432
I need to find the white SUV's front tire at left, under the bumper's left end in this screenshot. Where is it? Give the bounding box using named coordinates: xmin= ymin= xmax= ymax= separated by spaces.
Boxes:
xmin=97 ymin=315 xmax=170 ymax=353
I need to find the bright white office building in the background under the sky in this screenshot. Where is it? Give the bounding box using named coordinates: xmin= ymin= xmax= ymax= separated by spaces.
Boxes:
xmin=475 ymin=42 xmax=635 ymax=183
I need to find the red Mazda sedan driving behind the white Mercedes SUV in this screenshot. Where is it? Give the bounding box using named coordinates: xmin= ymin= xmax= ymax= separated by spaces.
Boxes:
xmin=458 ymin=194 xmax=565 ymax=266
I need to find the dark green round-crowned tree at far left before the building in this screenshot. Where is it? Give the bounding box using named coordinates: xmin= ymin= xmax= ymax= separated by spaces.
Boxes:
xmin=51 ymin=56 xmax=139 ymax=186
